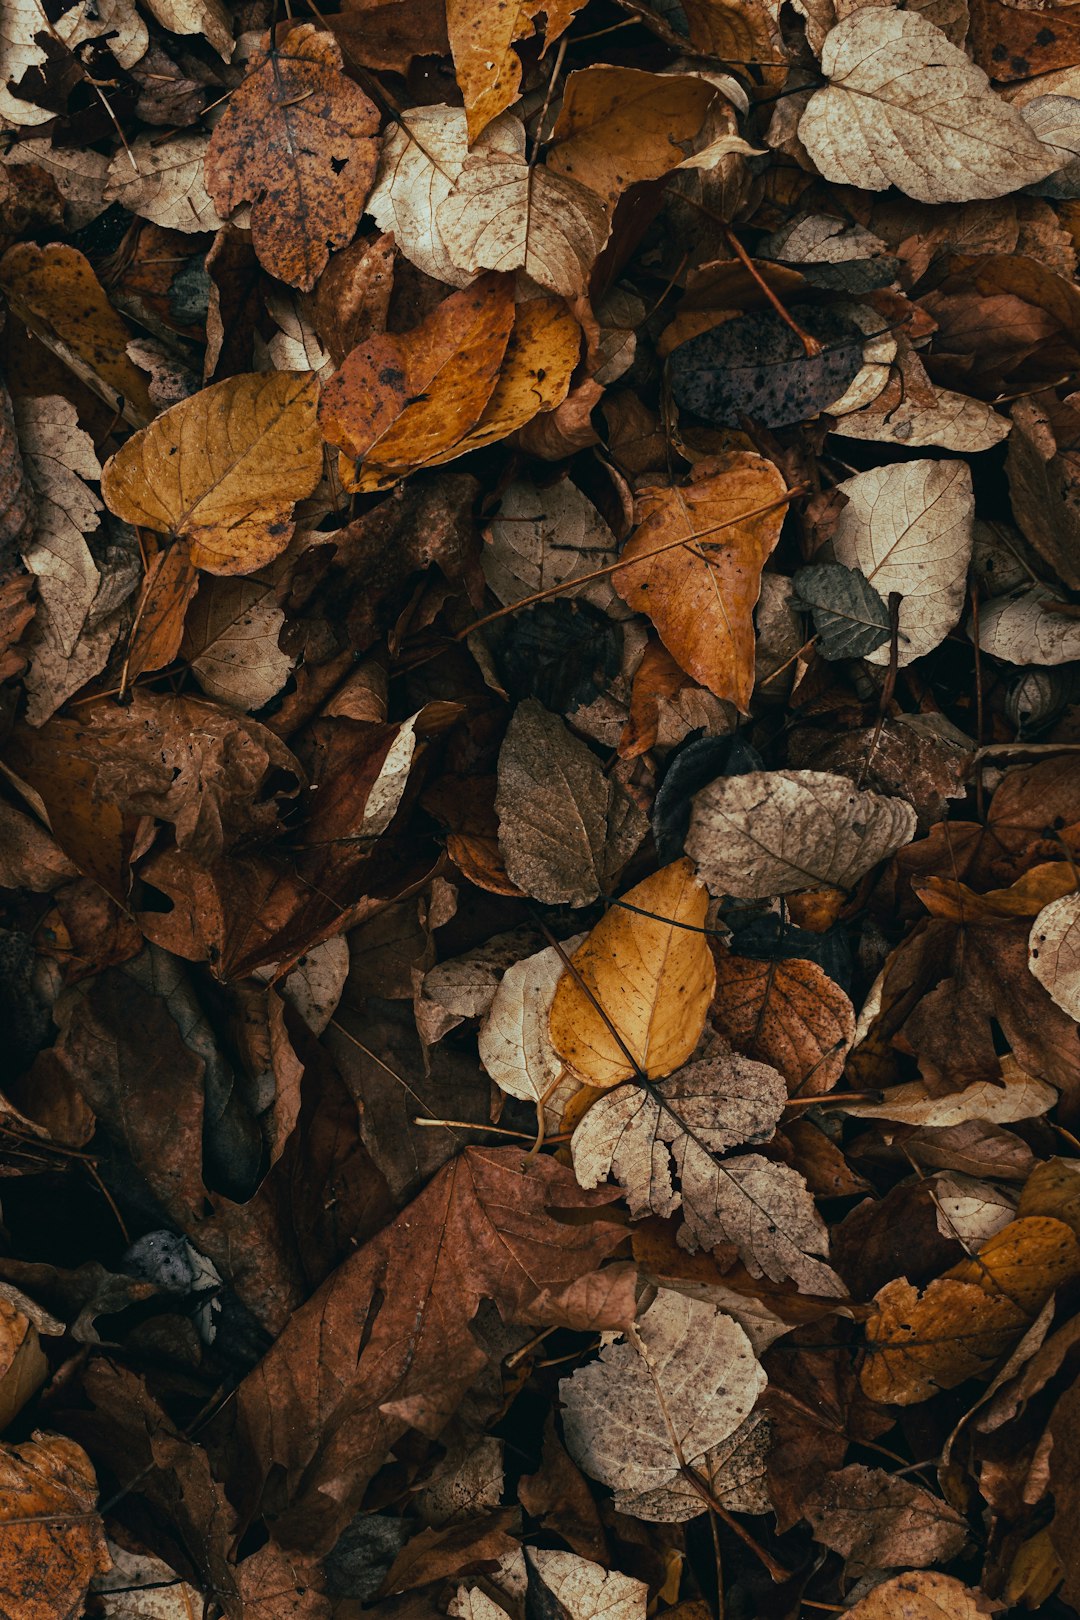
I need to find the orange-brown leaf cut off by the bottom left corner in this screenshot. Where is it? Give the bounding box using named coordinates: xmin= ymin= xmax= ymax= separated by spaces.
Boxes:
xmin=0 ymin=1432 xmax=110 ymax=1620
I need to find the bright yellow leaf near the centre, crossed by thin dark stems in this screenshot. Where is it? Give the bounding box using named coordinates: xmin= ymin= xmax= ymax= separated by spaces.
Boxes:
xmin=551 ymin=859 xmax=716 ymax=1087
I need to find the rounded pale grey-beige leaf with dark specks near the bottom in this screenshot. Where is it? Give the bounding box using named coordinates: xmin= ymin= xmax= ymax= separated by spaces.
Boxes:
xmin=560 ymin=1288 xmax=767 ymax=1523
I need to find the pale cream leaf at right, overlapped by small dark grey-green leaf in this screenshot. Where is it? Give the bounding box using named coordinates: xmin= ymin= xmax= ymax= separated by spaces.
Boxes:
xmin=832 ymin=456 xmax=975 ymax=667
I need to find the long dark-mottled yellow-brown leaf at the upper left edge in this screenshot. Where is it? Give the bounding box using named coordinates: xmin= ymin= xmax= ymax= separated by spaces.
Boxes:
xmin=0 ymin=241 xmax=154 ymax=426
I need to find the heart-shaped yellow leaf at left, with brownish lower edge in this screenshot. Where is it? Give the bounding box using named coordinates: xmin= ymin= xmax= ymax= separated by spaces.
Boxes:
xmin=102 ymin=371 xmax=322 ymax=573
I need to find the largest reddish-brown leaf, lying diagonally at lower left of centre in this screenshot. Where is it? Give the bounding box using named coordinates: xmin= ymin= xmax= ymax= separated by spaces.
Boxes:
xmin=228 ymin=1147 xmax=622 ymax=1547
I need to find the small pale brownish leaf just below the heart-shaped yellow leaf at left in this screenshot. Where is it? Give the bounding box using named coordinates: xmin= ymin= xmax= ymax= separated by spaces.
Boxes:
xmin=180 ymin=578 xmax=295 ymax=710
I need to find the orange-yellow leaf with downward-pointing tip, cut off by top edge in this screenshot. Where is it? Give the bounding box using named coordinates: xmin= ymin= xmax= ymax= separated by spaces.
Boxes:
xmin=447 ymin=0 xmax=583 ymax=143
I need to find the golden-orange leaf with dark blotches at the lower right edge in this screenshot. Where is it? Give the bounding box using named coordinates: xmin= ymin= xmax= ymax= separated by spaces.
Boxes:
xmin=860 ymin=1215 xmax=1080 ymax=1406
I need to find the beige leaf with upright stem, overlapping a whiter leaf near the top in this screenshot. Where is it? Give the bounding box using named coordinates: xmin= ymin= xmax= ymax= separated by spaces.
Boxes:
xmin=436 ymin=125 xmax=610 ymax=298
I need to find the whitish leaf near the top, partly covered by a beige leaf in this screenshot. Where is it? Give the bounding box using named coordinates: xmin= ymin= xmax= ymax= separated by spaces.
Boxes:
xmin=366 ymin=104 xmax=521 ymax=287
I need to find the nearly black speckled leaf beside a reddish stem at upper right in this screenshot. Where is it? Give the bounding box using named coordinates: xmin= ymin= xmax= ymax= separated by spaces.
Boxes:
xmin=667 ymin=306 xmax=865 ymax=428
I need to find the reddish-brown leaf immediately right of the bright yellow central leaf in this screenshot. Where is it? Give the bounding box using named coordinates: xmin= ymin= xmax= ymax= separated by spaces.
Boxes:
xmin=711 ymin=944 xmax=855 ymax=1097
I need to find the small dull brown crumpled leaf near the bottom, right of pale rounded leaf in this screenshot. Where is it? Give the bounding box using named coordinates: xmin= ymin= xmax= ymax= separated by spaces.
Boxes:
xmin=805 ymin=1463 xmax=968 ymax=1576
